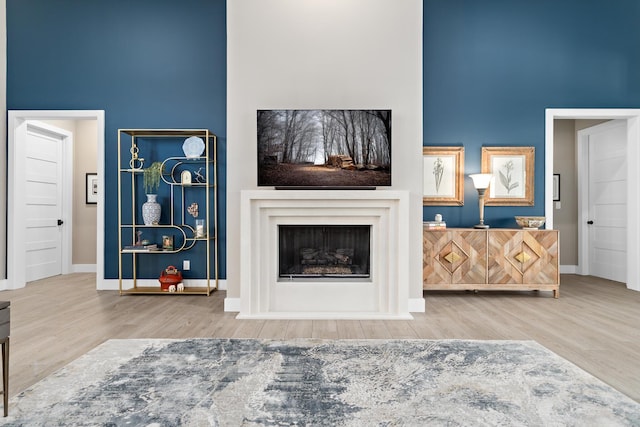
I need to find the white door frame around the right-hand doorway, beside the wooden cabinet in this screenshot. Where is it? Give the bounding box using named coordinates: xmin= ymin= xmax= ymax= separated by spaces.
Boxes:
xmin=544 ymin=108 xmax=640 ymax=291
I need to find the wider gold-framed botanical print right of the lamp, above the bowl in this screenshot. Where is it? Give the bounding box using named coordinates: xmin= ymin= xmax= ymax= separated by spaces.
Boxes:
xmin=482 ymin=147 xmax=535 ymax=206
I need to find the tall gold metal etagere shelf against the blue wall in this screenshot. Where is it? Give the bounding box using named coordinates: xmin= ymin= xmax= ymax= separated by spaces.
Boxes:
xmin=118 ymin=129 xmax=218 ymax=295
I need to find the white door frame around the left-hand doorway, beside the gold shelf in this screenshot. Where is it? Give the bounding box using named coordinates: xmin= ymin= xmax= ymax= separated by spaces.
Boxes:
xmin=6 ymin=110 xmax=104 ymax=289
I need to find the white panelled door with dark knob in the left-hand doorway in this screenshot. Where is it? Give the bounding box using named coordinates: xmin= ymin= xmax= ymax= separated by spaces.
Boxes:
xmin=24 ymin=127 xmax=63 ymax=282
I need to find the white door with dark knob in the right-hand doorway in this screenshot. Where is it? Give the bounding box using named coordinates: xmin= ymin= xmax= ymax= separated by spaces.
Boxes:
xmin=587 ymin=120 xmax=627 ymax=282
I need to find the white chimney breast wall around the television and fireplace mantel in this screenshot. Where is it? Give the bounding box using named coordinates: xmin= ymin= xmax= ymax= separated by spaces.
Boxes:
xmin=227 ymin=0 xmax=422 ymax=298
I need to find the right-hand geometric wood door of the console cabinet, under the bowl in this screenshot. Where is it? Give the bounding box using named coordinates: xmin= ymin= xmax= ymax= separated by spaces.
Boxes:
xmin=488 ymin=229 xmax=560 ymax=298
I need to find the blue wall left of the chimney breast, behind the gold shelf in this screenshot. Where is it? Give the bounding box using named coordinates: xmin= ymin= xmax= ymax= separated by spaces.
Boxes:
xmin=7 ymin=0 xmax=227 ymax=278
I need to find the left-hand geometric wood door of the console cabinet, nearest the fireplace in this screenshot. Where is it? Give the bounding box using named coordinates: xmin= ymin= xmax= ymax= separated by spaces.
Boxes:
xmin=422 ymin=229 xmax=487 ymax=289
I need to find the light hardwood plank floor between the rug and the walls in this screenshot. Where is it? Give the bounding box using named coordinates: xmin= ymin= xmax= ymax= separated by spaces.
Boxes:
xmin=0 ymin=274 xmax=640 ymax=402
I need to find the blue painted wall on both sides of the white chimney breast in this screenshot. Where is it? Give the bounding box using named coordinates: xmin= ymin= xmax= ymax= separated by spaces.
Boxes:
xmin=7 ymin=0 xmax=640 ymax=278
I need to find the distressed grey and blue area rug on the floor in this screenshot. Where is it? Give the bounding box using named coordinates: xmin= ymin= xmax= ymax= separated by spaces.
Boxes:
xmin=0 ymin=339 xmax=640 ymax=427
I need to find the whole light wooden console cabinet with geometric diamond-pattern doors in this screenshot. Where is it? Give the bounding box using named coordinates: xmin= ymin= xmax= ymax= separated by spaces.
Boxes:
xmin=423 ymin=228 xmax=560 ymax=298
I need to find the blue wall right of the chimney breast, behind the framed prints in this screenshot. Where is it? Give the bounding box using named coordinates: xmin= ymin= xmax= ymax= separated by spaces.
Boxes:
xmin=423 ymin=0 xmax=640 ymax=227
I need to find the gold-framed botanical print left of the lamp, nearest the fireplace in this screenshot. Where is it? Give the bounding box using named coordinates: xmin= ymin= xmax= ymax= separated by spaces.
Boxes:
xmin=422 ymin=147 xmax=464 ymax=206
